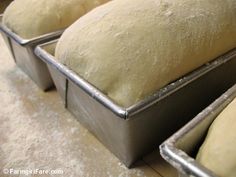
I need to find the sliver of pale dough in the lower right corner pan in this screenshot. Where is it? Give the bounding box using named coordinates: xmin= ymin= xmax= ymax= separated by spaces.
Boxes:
xmin=197 ymin=99 xmax=236 ymax=177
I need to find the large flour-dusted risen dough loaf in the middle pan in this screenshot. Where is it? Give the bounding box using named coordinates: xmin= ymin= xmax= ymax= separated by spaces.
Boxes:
xmin=56 ymin=0 xmax=236 ymax=107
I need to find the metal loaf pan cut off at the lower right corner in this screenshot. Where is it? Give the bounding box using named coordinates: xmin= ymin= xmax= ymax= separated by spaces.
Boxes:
xmin=160 ymin=84 xmax=236 ymax=177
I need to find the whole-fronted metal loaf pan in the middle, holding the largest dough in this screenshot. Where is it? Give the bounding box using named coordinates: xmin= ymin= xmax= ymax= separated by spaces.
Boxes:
xmin=35 ymin=40 xmax=236 ymax=167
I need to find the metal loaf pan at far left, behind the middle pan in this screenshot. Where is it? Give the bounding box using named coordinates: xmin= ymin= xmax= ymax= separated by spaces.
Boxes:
xmin=0 ymin=15 xmax=63 ymax=90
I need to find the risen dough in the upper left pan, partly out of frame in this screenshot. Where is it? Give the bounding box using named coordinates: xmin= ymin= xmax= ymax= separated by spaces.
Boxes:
xmin=3 ymin=0 xmax=108 ymax=39
